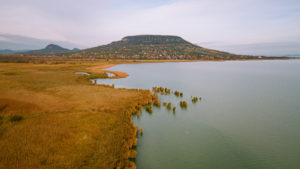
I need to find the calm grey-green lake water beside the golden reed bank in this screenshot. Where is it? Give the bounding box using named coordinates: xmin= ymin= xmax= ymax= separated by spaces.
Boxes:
xmin=97 ymin=60 xmax=300 ymax=169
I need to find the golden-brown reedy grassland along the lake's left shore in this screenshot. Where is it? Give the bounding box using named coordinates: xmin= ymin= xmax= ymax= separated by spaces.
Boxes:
xmin=0 ymin=61 xmax=151 ymax=169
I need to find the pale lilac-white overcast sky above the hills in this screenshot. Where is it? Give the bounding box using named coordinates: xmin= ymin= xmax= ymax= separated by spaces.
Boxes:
xmin=0 ymin=0 xmax=300 ymax=52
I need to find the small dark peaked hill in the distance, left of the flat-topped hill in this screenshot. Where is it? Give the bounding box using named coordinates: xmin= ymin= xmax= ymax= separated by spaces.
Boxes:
xmin=24 ymin=44 xmax=79 ymax=55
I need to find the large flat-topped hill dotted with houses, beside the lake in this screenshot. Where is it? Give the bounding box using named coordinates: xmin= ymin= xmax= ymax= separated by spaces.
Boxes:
xmin=72 ymin=35 xmax=253 ymax=59
